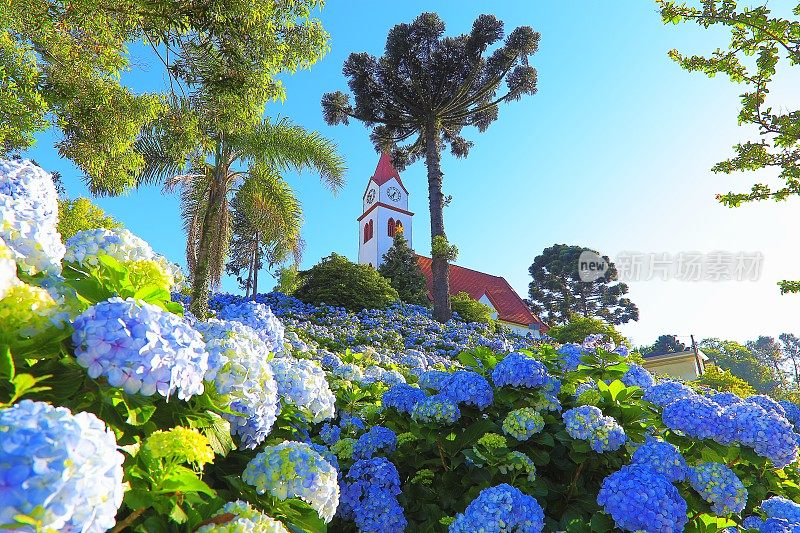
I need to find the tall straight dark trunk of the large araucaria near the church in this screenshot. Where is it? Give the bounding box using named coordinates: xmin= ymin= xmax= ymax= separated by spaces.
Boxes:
xmin=425 ymin=123 xmax=452 ymax=322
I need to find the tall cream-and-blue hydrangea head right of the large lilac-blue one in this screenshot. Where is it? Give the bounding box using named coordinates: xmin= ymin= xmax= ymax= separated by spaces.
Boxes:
xmin=196 ymin=319 xmax=278 ymax=449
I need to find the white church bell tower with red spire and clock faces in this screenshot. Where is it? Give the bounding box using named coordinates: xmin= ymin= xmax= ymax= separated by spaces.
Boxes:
xmin=358 ymin=152 xmax=414 ymax=268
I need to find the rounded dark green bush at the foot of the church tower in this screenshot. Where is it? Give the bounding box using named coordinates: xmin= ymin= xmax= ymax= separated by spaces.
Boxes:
xmin=294 ymin=254 xmax=399 ymax=311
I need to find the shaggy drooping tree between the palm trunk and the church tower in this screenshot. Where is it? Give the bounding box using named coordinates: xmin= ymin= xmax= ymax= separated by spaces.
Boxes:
xmin=225 ymin=186 xmax=303 ymax=298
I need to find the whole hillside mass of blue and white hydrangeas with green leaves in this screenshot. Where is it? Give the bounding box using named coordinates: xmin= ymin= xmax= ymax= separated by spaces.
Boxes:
xmin=0 ymin=156 xmax=800 ymax=533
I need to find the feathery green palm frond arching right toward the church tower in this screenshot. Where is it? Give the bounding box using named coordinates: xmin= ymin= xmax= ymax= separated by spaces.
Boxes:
xmin=234 ymin=118 xmax=346 ymax=193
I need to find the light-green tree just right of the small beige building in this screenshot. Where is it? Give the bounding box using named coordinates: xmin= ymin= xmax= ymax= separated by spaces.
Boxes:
xmin=700 ymin=339 xmax=780 ymax=394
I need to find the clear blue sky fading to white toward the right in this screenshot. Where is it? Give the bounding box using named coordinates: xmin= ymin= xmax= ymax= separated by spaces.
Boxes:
xmin=27 ymin=0 xmax=800 ymax=344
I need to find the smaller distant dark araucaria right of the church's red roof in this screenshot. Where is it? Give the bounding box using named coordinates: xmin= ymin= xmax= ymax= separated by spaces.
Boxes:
xmin=528 ymin=244 xmax=639 ymax=324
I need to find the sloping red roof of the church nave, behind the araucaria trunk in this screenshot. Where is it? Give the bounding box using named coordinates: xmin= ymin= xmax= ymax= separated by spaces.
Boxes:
xmin=417 ymin=255 xmax=549 ymax=333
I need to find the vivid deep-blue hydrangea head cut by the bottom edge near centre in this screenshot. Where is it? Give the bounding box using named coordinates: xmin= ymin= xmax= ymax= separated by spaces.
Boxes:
xmin=448 ymin=483 xmax=544 ymax=533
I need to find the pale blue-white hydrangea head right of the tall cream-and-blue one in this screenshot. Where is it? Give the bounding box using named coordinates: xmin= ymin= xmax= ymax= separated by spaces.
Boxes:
xmin=270 ymin=356 xmax=336 ymax=423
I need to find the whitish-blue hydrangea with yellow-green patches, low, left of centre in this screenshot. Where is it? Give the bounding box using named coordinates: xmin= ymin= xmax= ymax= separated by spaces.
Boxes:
xmin=242 ymin=441 xmax=339 ymax=522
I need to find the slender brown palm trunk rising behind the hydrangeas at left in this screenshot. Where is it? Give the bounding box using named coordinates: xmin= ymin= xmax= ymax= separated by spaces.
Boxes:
xmin=194 ymin=142 xmax=227 ymax=320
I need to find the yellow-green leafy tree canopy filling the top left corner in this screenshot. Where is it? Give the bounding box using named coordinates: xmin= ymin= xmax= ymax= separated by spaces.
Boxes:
xmin=0 ymin=0 xmax=327 ymax=194
